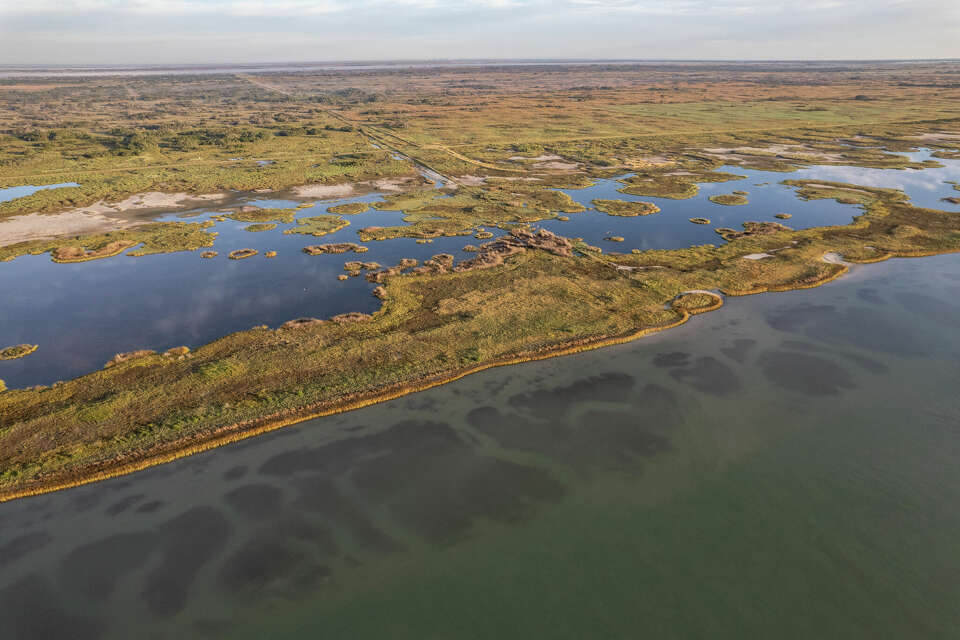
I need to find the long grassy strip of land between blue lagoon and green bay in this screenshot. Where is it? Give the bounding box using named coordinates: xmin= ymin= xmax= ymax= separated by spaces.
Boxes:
xmin=0 ymin=176 xmax=960 ymax=494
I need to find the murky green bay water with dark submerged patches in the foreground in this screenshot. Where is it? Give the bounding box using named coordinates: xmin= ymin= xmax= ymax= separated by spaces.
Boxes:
xmin=0 ymin=256 xmax=960 ymax=639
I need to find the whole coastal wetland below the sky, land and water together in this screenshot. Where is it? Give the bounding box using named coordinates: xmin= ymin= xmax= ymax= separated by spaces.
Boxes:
xmin=0 ymin=61 xmax=960 ymax=639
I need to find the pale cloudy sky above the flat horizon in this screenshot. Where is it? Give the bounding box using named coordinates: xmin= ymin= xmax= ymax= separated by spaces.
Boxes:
xmin=0 ymin=0 xmax=960 ymax=65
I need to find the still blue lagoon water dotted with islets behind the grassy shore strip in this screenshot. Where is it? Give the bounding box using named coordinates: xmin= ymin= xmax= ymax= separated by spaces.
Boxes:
xmin=0 ymin=151 xmax=960 ymax=388
